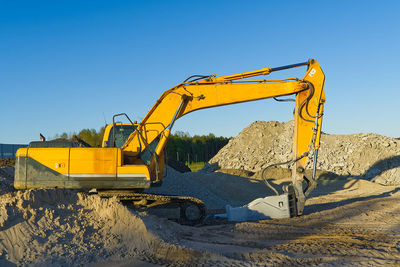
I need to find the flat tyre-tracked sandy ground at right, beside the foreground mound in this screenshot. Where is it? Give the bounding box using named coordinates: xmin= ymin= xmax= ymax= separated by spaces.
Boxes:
xmin=145 ymin=171 xmax=400 ymax=266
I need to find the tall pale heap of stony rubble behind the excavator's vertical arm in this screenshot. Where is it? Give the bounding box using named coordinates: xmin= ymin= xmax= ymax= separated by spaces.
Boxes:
xmin=209 ymin=121 xmax=400 ymax=185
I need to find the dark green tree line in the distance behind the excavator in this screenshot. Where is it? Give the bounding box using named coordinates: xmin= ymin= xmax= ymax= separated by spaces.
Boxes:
xmin=53 ymin=127 xmax=230 ymax=163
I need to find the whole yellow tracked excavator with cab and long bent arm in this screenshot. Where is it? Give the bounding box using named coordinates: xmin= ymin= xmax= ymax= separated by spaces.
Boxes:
xmin=14 ymin=59 xmax=325 ymax=223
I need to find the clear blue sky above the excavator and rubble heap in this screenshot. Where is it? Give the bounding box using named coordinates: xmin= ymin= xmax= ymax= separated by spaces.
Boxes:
xmin=0 ymin=0 xmax=400 ymax=143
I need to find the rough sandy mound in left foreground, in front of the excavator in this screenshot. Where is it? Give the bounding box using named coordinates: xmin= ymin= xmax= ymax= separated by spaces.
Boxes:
xmin=0 ymin=189 xmax=152 ymax=265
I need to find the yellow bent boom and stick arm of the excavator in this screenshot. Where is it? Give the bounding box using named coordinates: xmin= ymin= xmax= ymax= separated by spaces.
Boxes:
xmin=122 ymin=59 xmax=325 ymax=215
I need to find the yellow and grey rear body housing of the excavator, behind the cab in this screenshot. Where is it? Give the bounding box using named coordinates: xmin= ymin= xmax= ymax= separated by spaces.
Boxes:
xmin=14 ymin=147 xmax=150 ymax=189
